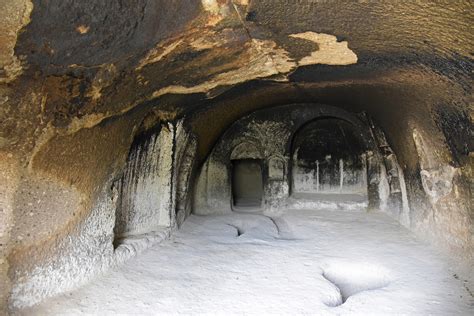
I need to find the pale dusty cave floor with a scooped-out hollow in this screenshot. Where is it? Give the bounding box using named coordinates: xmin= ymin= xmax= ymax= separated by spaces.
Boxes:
xmin=23 ymin=210 xmax=474 ymax=315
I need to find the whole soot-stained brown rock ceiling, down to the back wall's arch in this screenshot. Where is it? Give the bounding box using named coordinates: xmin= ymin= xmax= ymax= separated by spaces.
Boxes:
xmin=0 ymin=0 xmax=474 ymax=185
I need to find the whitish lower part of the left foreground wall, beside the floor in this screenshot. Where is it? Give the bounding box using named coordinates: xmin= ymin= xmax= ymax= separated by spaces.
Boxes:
xmin=10 ymin=185 xmax=116 ymax=307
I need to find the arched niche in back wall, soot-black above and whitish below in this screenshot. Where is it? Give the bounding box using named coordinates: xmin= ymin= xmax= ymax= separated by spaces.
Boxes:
xmin=291 ymin=117 xmax=367 ymax=200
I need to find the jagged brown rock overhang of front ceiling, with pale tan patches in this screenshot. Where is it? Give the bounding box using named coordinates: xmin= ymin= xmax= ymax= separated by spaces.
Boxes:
xmin=0 ymin=0 xmax=474 ymax=142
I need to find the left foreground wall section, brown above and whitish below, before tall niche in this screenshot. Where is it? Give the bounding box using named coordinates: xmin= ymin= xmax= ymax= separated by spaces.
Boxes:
xmin=9 ymin=112 xmax=142 ymax=306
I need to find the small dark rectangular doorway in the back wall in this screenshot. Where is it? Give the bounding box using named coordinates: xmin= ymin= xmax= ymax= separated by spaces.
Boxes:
xmin=232 ymin=159 xmax=263 ymax=207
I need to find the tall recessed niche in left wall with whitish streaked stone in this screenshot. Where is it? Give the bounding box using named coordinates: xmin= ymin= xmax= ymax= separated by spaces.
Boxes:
xmin=114 ymin=124 xmax=175 ymax=237
